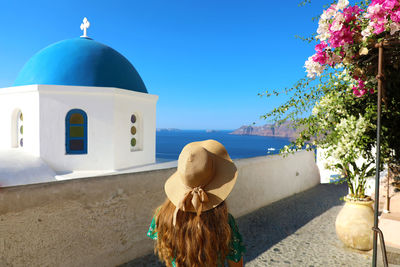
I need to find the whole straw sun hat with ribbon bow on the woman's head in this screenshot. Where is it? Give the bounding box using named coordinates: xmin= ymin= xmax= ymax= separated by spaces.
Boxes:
xmin=164 ymin=140 xmax=238 ymax=225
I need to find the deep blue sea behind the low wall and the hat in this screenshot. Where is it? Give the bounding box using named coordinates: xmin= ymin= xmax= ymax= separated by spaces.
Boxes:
xmin=156 ymin=130 xmax=290 ymax=162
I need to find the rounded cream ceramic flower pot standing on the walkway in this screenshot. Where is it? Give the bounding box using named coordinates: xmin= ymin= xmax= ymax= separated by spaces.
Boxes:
xmin=336 ymin=198 xmax=374 ymax=250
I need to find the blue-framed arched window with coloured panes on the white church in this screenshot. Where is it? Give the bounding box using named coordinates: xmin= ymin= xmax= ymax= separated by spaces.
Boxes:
xmin=65 ymin=109 xmax=87 ymax=154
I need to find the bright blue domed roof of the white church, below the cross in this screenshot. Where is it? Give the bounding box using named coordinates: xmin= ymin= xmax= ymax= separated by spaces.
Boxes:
xmin=14 ymin=38 xmax=147 ymax=93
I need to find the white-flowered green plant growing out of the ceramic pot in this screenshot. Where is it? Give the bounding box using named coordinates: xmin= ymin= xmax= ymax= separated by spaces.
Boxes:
xmin=312 ymin=79 xmax=375 ymax=199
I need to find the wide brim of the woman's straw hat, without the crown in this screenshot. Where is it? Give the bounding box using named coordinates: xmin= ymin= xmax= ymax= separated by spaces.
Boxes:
xmin=164 ymin=142 xmax=238 ymax=212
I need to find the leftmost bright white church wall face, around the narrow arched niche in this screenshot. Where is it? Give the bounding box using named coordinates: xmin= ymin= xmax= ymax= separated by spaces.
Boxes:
xmin=0 ymin=85 xmax=40 ymax=156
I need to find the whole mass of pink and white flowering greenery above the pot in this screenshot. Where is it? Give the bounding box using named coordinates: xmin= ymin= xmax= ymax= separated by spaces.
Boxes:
xmin=262 ymin=0 xmax=400 ymax=198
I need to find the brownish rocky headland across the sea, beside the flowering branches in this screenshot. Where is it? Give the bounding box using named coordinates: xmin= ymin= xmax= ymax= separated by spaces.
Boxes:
xmin=230 ymin=122 xmax=298 ymax=140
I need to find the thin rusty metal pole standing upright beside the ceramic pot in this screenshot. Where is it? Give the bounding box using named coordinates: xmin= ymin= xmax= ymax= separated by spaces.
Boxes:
xmin=372 ymin=43 xmax=384 ymax=267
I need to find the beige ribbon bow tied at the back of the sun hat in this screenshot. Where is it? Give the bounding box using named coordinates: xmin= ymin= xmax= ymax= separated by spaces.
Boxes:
xmin=172 ymin=186 xmax=208 ymax=226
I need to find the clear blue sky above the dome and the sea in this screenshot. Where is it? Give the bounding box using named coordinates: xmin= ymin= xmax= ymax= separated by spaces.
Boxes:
xmin=0 ymin=0 xmax=328 ymax=129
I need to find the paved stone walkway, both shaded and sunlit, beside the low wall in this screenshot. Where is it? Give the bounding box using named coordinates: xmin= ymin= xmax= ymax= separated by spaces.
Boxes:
xmin=123 ymin=184 xmax=371 ymax=267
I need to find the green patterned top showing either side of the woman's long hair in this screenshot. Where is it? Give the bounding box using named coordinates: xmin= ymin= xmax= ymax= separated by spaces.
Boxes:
xmin=147 ymin=214 xmax=246 ymax=267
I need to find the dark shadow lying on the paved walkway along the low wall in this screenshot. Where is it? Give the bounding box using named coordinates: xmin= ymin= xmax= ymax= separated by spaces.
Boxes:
xmin=119 ymin=184 xmax=347 ymax=267
